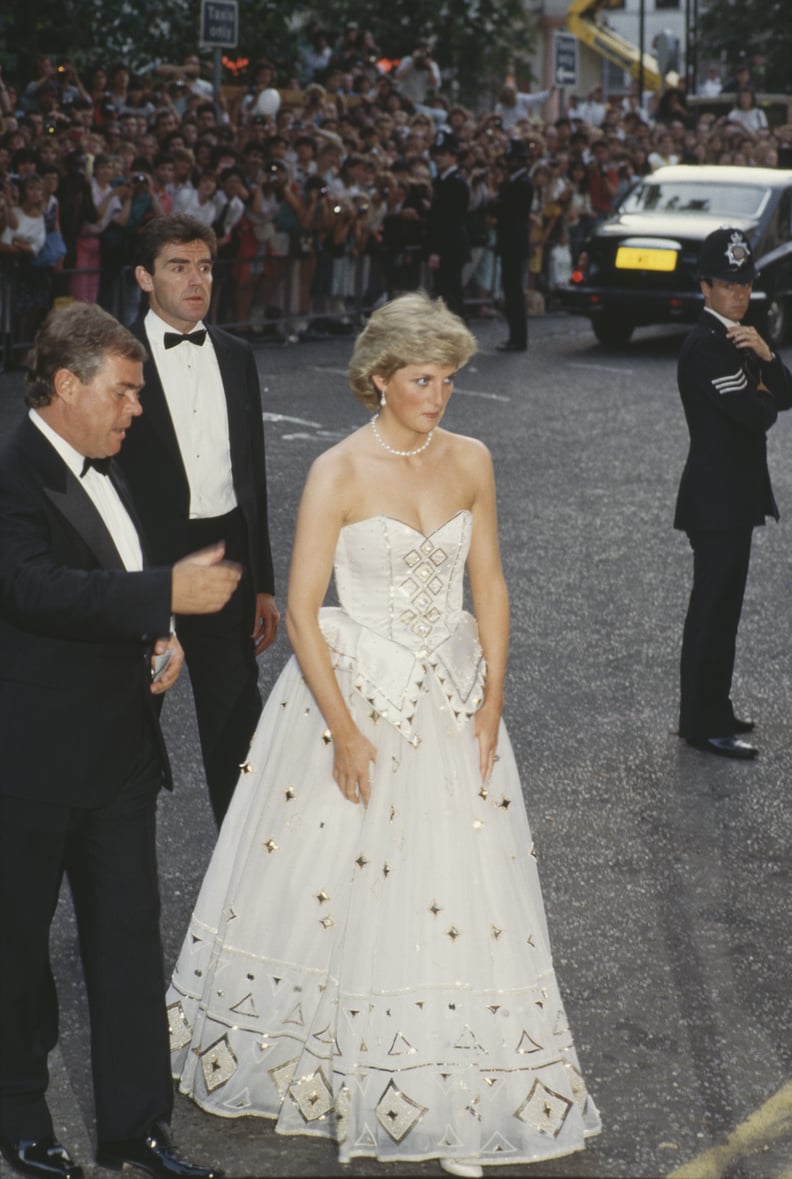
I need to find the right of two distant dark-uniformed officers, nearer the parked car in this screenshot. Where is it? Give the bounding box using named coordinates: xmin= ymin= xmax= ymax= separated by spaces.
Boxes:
xmin=491 ymin=139 xmax=534 ymax=353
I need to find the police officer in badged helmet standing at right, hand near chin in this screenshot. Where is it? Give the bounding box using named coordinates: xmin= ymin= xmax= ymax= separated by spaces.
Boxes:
xmin=674 ymin=229 xmax=792 ymax=760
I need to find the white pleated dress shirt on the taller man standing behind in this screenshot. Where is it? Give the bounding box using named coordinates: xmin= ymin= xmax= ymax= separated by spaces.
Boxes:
xmin=141 ymin=310 xmax=237 ymax=520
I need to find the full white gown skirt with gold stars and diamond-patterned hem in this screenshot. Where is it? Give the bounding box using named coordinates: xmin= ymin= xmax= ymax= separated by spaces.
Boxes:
xmin=169 ymin=659 xmax=600 ymax=1165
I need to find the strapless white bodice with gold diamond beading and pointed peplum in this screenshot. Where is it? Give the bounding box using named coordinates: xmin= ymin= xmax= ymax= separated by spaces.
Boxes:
xmin=319 ymin=511 xmax=484 ymax=737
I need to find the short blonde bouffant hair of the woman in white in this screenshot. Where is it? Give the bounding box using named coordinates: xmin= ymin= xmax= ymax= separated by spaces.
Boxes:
xmin=348 ymin=291 xmax=479 ymax=410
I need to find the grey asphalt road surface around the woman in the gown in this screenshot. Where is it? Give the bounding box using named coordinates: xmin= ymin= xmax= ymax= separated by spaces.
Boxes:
xmin=0 ymin=315 xmax=792 ymax=1179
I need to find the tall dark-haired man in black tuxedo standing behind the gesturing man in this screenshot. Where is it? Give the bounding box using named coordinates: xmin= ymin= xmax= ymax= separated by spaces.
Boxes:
xmin=120 ymin=215 xmax=279 ymax=825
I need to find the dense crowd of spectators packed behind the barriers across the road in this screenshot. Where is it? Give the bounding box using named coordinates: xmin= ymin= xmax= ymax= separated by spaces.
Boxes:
xmin=0 ymin=22 xmax=791 ymax=351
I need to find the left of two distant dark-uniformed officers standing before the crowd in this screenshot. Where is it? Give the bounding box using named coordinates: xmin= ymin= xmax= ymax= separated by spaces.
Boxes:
xmin=427 ymin=130 xmax=470 ymax=318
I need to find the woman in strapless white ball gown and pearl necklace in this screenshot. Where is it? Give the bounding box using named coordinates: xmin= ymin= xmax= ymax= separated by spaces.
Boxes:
xmin=169 ymin=292 xmax=600 ymax=1177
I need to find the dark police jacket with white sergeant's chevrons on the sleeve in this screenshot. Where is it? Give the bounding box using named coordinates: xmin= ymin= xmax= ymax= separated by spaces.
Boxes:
xmin=674 ymin=310 xmax=792 ymax=533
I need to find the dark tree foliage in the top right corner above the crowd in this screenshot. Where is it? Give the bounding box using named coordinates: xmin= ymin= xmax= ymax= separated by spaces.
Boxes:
xmin=699 ymin=0 xmax=792 ymax=94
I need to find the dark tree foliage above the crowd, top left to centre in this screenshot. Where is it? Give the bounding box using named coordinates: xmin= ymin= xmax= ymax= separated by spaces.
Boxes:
xmin=0 ymin=0 xmax=534 ymax=103
